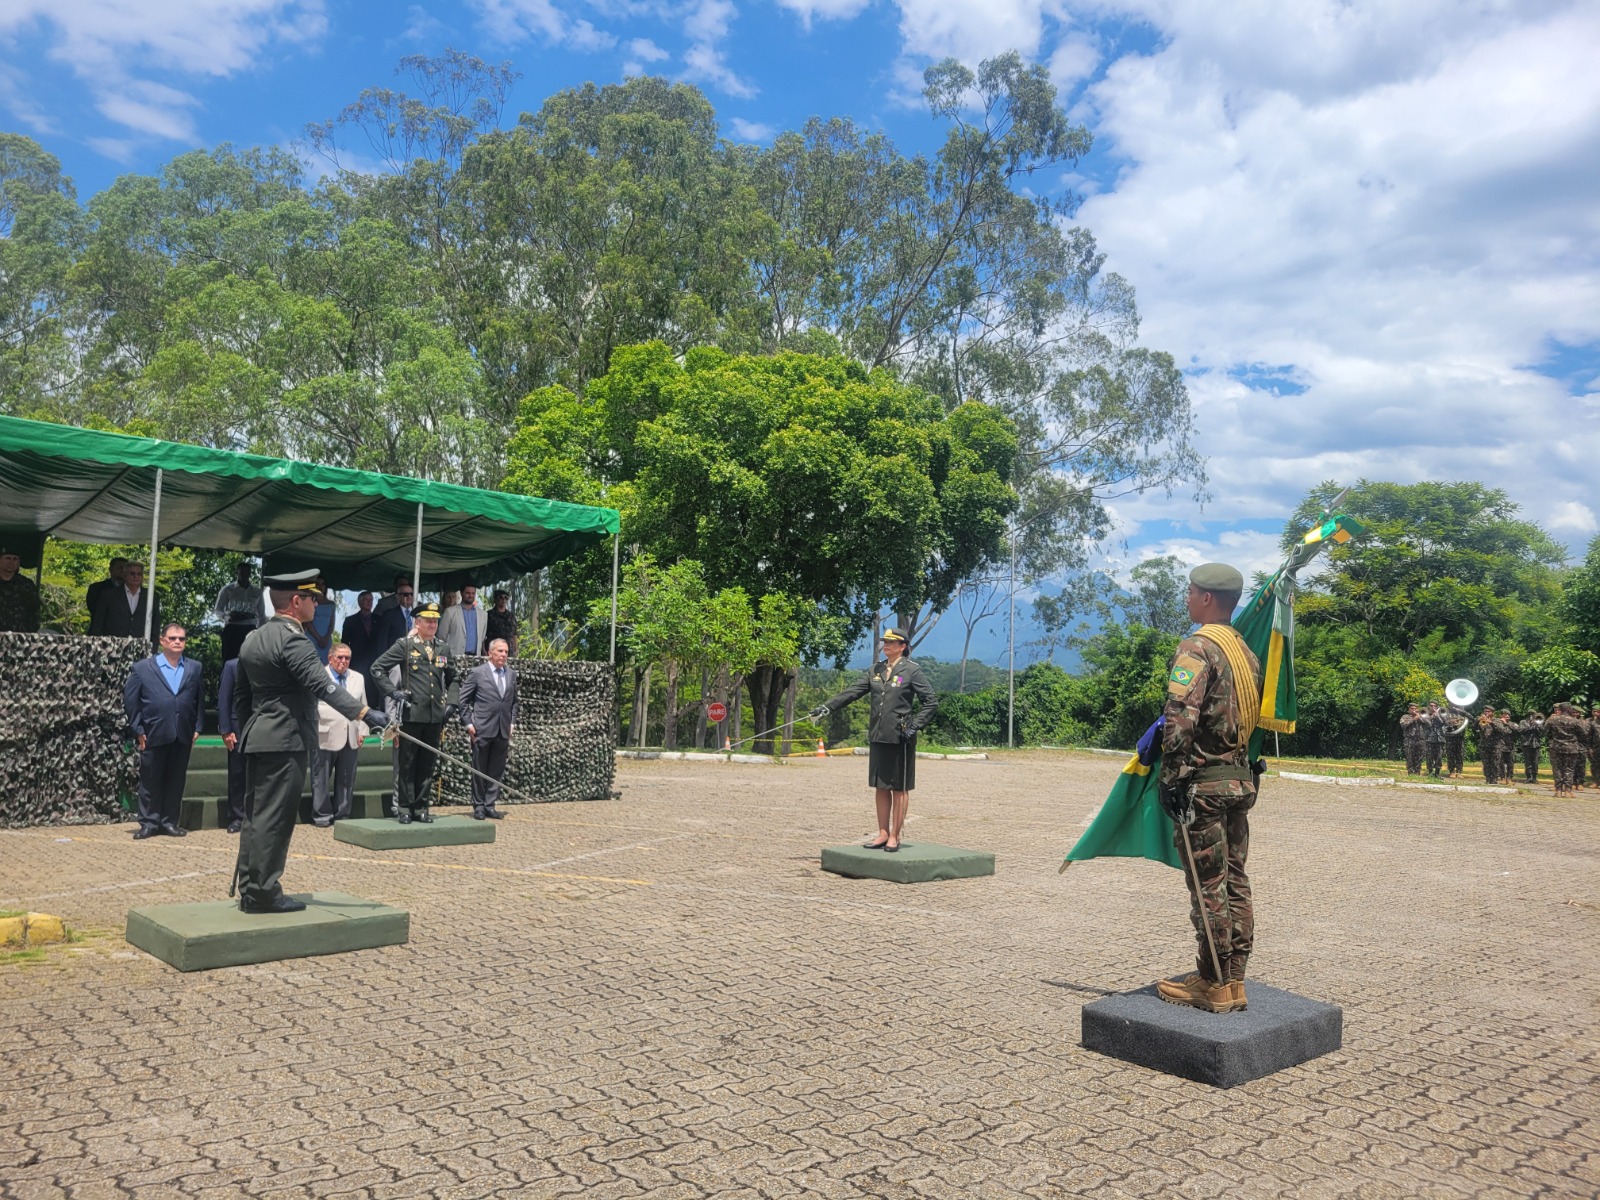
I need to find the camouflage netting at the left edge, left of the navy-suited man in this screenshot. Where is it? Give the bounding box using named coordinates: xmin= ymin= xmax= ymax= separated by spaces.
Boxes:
xmin=0 ymin=634 xmax=150 ymax=829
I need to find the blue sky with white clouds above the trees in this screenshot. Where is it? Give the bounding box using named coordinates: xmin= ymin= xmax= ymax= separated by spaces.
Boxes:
xmin=0 ymin=0 xmax=1600 ymax=661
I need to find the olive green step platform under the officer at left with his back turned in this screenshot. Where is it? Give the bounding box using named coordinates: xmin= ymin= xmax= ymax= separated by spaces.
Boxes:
xmin=126 ymin=891 xmax=411 ymax=971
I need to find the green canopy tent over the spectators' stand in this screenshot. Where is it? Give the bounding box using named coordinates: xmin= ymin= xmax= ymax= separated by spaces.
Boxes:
xmin=0 ymin=416 xmax=621 ymax=661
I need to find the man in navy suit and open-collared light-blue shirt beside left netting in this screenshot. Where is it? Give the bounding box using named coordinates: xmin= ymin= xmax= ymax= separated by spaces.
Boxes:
xmin=123 ymin=624 xmax=205 ymax=840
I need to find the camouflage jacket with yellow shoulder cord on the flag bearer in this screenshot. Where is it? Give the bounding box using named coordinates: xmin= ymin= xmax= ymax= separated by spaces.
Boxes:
xmin=1162 ymin=634 xmax=1261 ymax=795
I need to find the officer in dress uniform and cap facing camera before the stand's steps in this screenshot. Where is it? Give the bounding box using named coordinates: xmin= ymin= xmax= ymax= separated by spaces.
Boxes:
xmin=368 ymin=603 xmax=456 ymax=826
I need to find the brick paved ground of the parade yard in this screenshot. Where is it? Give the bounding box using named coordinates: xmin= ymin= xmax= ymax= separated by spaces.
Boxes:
xmin=0 ymin=752 xmax=1600 ymax=1200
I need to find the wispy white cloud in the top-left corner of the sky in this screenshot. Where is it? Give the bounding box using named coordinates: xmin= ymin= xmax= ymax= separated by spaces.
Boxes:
xmin=0 ymin=0 xmax=328 ymax=145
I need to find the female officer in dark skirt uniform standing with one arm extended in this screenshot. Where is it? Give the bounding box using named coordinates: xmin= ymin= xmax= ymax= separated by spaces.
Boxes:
xmin=811 ymin=629 xmax=939 ymax=854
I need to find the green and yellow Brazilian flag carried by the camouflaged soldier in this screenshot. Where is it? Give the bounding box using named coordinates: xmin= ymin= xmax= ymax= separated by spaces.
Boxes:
xmin=1062 ymin=512 xmax=1366 ymax=870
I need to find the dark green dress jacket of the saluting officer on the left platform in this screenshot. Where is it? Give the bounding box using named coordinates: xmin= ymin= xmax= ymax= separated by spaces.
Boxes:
xmin=234 ymin=616 xmax=366 ymax=754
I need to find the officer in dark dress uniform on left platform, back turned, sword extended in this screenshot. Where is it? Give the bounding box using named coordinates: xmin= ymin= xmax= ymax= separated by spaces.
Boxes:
xmin=234 ymin=570 xmax=389 ymax=912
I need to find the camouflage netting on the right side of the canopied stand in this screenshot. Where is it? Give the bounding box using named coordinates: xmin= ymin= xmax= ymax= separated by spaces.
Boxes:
xmin=428 ymin=656 xmax=616 ymax=805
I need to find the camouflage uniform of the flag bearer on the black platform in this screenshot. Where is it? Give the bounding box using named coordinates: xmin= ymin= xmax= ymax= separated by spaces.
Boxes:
xmin=1162 ymin=635 xmax=1261 ymax=982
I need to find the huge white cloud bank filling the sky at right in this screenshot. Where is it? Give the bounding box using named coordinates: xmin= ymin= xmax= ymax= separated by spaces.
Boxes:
xmin=1080 ymin=0 xmax=1600 ymax=550
